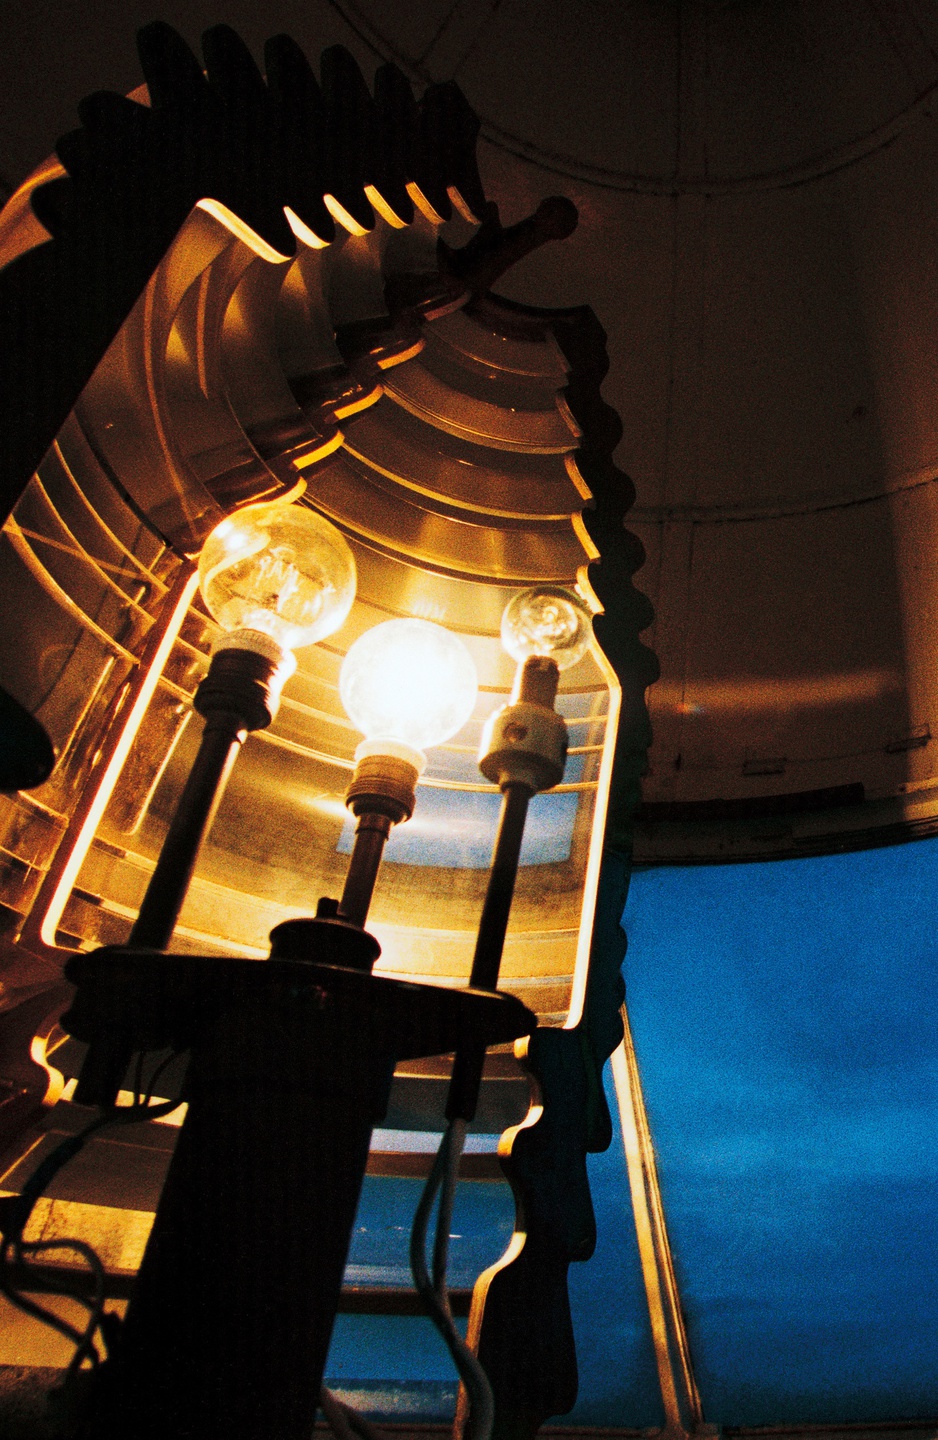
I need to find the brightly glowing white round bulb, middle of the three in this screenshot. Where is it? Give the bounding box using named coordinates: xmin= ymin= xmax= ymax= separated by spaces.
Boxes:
xmin=339 ymin=619 xmax=478 ymax=750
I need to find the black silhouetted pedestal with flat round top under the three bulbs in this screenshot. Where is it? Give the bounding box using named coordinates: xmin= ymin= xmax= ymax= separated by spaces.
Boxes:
xmin=63 ymin=916 xmax=535 ymax=1440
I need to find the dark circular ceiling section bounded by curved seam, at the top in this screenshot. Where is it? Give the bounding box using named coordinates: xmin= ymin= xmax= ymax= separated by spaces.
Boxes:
xmin=328 ymin=0 xmax=938 ymax=193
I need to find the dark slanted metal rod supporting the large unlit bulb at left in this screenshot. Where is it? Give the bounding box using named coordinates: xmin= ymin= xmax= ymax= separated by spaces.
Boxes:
xmin=127 ymin=710 xmax=248 ymax=950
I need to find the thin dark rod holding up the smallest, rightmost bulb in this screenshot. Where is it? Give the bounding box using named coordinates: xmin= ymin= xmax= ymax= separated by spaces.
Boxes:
xmin=447 ymin=783 xmax=532 ymax=1120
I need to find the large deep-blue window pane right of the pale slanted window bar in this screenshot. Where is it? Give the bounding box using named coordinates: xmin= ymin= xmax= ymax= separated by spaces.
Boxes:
xmin=625 ymin=841 xmax=938 ymax=1424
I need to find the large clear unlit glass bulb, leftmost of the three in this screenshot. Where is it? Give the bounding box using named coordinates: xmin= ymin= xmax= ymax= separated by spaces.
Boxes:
xmin=199 ymin=501 xmax=356 ymax=649
